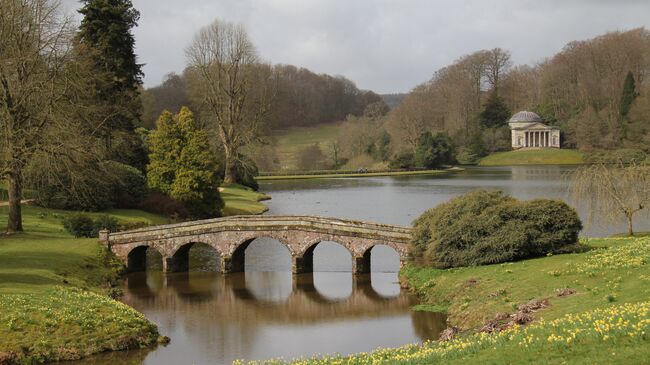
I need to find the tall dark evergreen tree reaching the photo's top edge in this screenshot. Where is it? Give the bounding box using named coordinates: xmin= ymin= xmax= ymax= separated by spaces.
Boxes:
xmin=75 ymin=0 xmax=146 ymax=168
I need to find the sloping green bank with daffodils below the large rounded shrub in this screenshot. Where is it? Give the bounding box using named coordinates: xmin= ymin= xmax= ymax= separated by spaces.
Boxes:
xmin=240 ymin=237 xmax=650 ymax=365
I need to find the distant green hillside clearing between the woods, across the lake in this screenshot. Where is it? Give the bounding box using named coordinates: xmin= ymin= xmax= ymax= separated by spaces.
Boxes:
xmin=274 ymin=123 xmax=341 ymax=170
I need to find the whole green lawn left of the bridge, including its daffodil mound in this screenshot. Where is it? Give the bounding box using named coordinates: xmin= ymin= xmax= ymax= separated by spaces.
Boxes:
xmin=0 ymin=206 xmax=166 ymax=363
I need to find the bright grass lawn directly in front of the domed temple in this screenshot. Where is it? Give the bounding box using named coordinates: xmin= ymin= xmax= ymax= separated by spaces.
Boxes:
xmin=479 ymin=148 xmax=584 ymax=166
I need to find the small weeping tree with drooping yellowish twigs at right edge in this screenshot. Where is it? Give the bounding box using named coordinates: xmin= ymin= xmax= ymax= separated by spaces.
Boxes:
xmin=569 ymin=165 xmax=650 ymax=236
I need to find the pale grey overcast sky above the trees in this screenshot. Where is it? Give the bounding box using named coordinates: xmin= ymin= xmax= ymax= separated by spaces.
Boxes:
xmin=63 ymin=0 xmax=650 ymax=93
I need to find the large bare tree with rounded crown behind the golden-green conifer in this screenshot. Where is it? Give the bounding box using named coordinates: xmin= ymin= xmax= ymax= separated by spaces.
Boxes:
xmin=186 ymin=20 xmax=272 ymax=183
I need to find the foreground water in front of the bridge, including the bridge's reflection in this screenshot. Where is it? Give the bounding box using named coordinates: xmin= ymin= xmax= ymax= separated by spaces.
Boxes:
xmin=74 ymin=271 xmax=445 ymax=365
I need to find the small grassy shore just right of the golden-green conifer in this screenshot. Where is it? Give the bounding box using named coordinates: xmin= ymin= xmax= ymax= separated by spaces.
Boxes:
xmin=219 ymin=184 xmax=271 ymax=216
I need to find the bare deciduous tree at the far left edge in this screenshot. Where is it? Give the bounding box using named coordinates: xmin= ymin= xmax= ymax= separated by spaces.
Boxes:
xmin=0 ymin=0 xmax=71 ymax=232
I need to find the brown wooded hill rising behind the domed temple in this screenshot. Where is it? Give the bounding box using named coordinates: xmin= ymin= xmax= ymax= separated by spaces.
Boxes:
xmin=386 ymin=28 xmax=650 ymax=155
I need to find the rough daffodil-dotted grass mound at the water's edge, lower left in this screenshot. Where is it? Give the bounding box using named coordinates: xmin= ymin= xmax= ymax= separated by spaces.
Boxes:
xmin=0 ymin=286 xmax=158 ymax=362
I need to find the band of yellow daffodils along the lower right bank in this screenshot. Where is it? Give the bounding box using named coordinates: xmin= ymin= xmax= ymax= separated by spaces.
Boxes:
xmin=240 ymin=302 xmax=650 ymax=365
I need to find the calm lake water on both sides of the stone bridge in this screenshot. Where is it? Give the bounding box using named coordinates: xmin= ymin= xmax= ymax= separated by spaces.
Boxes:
xmin=69 ymin=166 xmax=648 ymax=365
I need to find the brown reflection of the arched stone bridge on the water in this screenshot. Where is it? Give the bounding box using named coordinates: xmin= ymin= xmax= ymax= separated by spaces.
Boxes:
xmin=123 ymin=272 xmax=440 ymax=326
